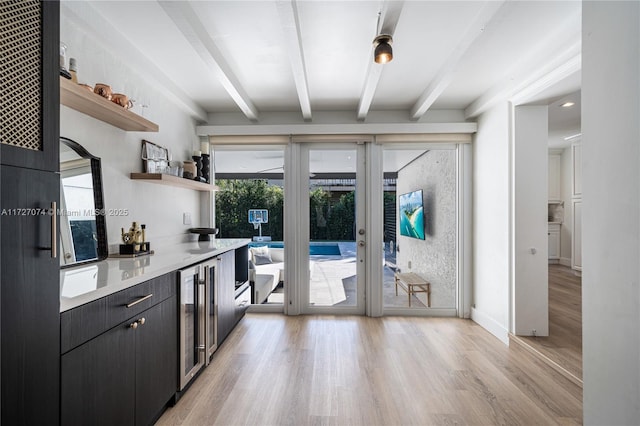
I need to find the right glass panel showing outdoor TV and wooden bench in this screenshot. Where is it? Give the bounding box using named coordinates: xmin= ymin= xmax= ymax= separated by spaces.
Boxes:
xmin=383 ymin=145 xmax=458 ymax=313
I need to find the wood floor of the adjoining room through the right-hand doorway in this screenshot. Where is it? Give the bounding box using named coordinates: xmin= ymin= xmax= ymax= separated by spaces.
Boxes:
xmin=519 ymin=265 xmax=582 ymax=381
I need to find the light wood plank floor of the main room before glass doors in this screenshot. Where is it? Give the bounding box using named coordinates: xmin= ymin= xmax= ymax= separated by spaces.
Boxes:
xmin=157 ymin=314 xmax=582 ymax=425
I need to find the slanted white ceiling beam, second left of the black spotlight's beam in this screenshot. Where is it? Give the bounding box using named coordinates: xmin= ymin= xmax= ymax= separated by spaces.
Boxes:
xmin=159 ymin=1 xmax=258 ymax=121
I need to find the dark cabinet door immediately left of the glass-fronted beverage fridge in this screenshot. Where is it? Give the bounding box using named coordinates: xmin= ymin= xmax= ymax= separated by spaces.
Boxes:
xmin=135 ymin=297 xmax=178 ymax=425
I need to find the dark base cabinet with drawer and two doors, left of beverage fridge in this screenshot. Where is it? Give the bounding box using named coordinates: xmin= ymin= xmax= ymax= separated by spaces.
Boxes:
xmin=61 ymin=273 xmax=178 ymax=425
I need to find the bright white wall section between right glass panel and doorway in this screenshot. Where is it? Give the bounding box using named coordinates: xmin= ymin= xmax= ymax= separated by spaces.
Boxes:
xmin=471 ymin=102 xmax=510 ymax=343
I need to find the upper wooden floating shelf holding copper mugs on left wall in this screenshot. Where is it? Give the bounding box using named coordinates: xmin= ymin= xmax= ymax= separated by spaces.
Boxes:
xmin=60 ymin=77 xmax=159 ymax=132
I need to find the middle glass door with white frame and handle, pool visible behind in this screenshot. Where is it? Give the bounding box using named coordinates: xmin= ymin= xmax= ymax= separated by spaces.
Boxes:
xmin=299 ymin=143 xmax=367 ymax=314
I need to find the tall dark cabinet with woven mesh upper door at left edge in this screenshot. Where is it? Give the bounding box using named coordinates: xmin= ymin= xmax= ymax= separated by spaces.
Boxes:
xmin=0 ymin=0 xmax=60 ymax=425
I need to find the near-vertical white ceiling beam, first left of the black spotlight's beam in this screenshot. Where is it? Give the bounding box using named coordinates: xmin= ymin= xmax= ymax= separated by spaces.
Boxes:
xmin=276 ymin=0 xmax=312 ymax=121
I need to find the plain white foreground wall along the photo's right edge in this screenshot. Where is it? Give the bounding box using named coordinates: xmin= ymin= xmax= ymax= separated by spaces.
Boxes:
xmin=582 ymin=1 xmax=640 ymax=425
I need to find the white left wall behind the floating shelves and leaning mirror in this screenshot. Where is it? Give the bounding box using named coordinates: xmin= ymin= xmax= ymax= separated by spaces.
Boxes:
xmin=60 ymin=14 xmax=200 ymax=252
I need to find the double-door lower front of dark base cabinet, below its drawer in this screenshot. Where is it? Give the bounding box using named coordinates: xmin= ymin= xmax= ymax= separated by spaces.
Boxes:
xmin=61 ymin=297 xmax=178 ymax=426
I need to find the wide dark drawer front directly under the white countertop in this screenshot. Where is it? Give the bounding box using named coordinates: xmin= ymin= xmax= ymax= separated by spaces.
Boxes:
xmin=60 ymin=272 xmax=178 ymax=353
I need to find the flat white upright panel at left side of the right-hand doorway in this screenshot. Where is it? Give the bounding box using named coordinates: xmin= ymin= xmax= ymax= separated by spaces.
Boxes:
xmin=512 ymin=106 xmax=549 ymax=336
